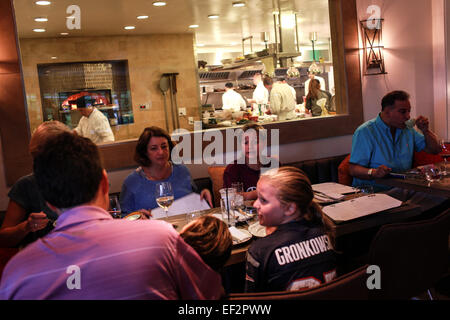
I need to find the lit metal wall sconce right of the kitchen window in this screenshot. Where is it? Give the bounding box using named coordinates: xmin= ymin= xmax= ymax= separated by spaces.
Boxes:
xmin=361 ymin=19 xmax=386 ymax=75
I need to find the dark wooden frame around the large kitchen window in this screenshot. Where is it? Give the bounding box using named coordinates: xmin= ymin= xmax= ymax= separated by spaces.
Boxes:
xmin=0 ymin=0 xmax=364 ymax=181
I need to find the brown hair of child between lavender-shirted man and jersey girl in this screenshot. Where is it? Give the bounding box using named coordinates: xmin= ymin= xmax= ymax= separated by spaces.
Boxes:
xmin=180 ymin=215 xmax=233 ymax=271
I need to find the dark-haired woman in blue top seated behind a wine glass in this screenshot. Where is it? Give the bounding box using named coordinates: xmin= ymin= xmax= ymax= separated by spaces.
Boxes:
xmin=120 ymin=127 xmax=212 ymax=217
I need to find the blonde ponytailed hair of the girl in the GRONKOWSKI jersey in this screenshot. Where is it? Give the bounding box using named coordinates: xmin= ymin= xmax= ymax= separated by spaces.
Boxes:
xmin=260 ymin=167 xmax=323 ymax=224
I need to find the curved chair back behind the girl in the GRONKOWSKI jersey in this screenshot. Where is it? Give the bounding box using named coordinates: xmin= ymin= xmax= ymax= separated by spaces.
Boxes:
xmin=228 ymin=265 xmax=368 ymax=300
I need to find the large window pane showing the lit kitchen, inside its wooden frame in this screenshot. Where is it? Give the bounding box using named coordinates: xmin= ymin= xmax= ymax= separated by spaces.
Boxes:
xmin=14 ymin=0 xmax=340 ymax=141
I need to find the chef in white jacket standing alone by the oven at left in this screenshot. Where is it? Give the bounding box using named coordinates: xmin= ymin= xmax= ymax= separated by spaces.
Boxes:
xmin=74 ymin=97 xmax=114 ymax=144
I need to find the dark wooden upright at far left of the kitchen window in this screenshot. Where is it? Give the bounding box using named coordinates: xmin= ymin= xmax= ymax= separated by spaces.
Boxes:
xmin=0 ymin=0 xmax=32 ymax=186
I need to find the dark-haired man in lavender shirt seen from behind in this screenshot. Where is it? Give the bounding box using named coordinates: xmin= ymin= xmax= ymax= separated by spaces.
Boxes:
xmin=0 ymin=133 xmax=223 ymax=300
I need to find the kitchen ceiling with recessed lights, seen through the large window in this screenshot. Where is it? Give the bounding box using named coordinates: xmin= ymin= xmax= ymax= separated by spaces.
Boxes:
xmin=14 ymin=0 xmax=330 ymax=52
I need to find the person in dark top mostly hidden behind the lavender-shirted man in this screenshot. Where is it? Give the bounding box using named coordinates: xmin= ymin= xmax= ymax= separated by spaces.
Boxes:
xmin=0 ymin=121 xmax=71 ymax=248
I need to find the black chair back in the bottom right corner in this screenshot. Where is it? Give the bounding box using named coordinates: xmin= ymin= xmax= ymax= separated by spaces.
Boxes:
xmin=368 ymin=209 xmax=450 ymax=299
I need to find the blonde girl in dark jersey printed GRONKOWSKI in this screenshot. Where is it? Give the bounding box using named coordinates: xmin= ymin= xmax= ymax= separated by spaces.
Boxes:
xmin=245 ymin=167 xmax=336 ymax=292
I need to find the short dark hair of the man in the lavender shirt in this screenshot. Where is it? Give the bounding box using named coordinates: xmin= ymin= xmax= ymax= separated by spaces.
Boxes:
xmin=33 ymin=132 xmax=103 ymax=209
